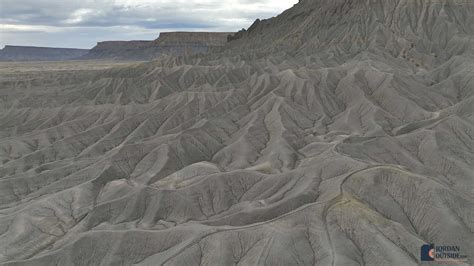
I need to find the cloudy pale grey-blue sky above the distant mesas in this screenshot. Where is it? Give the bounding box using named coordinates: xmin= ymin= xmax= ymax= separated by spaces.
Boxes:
xmin=0 ymin=0 xmax=298 ymax=48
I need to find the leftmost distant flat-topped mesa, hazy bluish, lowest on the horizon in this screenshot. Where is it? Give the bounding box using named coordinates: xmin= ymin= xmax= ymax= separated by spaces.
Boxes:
xmin=0 ymin=45 xmax=89 ymax=61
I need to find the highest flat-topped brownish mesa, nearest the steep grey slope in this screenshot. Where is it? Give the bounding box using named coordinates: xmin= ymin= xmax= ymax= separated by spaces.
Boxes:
xmin=154 ymin=32 xmax=233 ymax=46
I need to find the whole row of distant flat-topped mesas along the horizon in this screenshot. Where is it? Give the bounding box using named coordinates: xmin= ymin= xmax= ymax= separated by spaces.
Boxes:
xmin=0 ymin=32 xmax=234 ymax=61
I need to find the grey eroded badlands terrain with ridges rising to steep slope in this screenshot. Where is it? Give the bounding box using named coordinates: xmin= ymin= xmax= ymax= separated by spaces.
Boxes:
xmin=0 ymin=0 xmax=474 ymax=265
